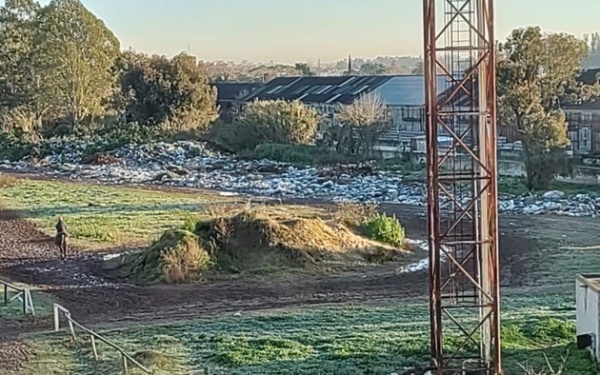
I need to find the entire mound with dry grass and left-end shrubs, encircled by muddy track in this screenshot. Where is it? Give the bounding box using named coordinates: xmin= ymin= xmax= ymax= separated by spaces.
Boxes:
xmin=115 ymin=204 xmax=410 ymax=283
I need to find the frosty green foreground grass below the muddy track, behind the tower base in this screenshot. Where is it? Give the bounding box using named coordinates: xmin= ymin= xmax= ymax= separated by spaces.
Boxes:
xmin=12 ymin=295 xmax=600 ymax=375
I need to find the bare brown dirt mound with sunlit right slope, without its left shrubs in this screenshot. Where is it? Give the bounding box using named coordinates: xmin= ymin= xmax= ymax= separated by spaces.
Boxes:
xmin=196 ymin=211 xmax=407 ymax=272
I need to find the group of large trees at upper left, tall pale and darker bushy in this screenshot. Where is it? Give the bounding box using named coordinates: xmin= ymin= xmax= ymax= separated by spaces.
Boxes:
xmin=0 ymin=0 xmax=217 ymax=142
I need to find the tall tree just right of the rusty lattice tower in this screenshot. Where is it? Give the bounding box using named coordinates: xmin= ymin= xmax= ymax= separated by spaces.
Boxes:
xmin=498 ymin=27 xmax=598 ymax=189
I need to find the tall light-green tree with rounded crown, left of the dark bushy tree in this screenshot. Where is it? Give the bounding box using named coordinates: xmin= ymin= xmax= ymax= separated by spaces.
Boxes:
xmin=35 ymin=0 xmax=120 ymax=124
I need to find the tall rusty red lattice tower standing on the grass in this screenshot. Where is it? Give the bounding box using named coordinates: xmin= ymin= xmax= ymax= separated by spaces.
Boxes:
xmin=423 ymin=0 xmax=501 ymax=375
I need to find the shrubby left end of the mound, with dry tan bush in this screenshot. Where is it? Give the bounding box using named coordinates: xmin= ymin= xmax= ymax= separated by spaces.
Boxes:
xmin=122 ymin=230 xmax=210 ymax=283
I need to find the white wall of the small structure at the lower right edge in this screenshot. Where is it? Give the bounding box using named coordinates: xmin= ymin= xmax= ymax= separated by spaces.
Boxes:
xmin=575 ymin=277 xmax=600 ymax=358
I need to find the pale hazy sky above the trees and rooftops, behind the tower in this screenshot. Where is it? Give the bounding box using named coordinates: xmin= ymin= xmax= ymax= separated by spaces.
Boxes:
xmin=21 ymin=0 xmax=600 ymax=62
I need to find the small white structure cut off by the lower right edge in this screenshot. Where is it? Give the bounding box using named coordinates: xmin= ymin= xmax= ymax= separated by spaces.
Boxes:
xmin=575 ymin=274 xmax=600 ymax=359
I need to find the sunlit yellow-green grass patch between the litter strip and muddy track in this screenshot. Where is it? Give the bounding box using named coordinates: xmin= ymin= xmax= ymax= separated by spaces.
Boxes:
xmin=0 ymin=180 xmax=237 ymax=249
